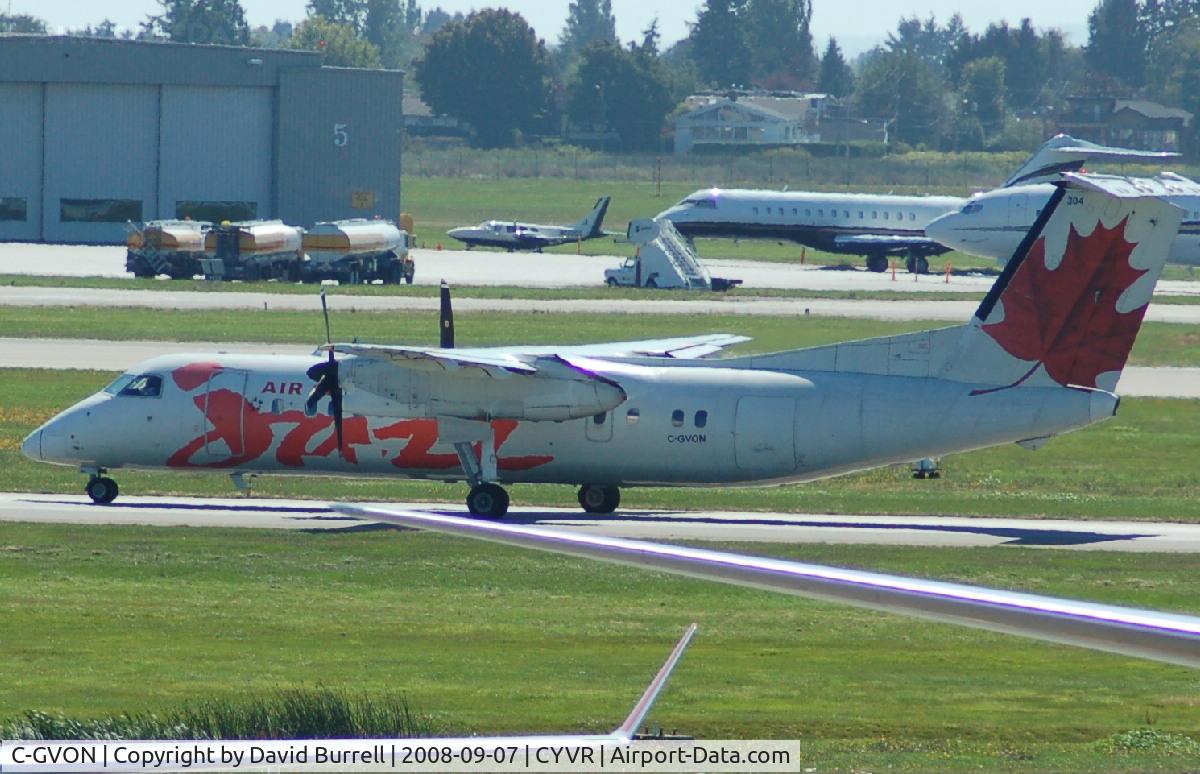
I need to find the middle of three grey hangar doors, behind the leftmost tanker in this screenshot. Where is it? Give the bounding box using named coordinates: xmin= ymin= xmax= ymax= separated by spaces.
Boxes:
xmin=42 ymin=83 xmax=158 ymax=242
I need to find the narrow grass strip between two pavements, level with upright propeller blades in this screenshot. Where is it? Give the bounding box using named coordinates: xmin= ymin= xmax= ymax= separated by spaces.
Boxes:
xmin=0 ymin=303 xmax=1200 ymax=366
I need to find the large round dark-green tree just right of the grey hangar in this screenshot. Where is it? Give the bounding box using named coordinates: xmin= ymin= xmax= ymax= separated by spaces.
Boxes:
xmin=413 ymin=8 xmax=550 ymax=148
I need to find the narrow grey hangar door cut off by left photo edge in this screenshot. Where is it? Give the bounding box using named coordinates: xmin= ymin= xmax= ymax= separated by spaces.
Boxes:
xmin=0 ymin=83 xmax=42 ymax=241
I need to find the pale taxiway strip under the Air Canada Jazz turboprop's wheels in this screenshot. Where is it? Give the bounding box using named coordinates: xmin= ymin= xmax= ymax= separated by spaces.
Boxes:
xmin=0 ymin=493 xmax=1200 ymax=553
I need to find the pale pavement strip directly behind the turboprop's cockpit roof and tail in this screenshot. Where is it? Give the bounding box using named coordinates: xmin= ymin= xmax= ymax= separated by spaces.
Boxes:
xmin=0 ymin=337 xmax=1200 ymax=400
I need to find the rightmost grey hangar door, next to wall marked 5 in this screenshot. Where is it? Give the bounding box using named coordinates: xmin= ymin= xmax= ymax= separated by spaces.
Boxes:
xmin=158 ymin=85 xmax=275 ymax=222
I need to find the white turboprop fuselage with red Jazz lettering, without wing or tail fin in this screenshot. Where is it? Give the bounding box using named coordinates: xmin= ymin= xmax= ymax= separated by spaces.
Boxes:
xmin=23 ymin=355 xmax=1116 ymax=486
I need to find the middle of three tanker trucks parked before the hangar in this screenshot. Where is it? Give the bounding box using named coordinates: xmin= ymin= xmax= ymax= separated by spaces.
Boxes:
xmin=200 ymin=221 xmax=304 ymax=282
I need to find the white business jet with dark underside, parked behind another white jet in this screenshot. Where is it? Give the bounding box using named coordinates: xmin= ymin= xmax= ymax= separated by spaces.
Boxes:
xmin=656 ymin=134 xmax=1178 ymax=274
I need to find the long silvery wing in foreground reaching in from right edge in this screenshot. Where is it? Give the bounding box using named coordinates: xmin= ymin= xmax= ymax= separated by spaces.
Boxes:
xmin=331 ymin=504 xmax=1200 ymax=668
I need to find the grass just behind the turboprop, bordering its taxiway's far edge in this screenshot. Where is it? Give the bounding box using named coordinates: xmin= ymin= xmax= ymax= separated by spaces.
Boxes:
xmin=7 ymin=370 xmax=1200 ymax=521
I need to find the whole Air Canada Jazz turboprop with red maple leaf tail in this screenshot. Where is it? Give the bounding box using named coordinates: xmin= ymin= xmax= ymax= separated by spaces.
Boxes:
xmin=22 ymin=175 xmax=1182 ymax=518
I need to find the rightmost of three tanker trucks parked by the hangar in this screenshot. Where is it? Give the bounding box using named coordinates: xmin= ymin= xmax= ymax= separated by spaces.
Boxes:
xmin=302 ymin=218 xmax=414 ymax=284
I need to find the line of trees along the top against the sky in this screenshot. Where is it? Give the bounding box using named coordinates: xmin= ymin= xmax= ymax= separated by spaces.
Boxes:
xmin=0 ymin=0 xmax=1200 ymax=150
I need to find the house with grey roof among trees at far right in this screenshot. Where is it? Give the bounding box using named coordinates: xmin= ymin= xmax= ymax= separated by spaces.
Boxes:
xmin=1058 ymin=95 xmax=1194 ymax=151
